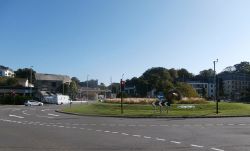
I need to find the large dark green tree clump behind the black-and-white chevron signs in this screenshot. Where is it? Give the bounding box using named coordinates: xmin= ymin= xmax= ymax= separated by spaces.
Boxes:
xmin=126 ymin=67 xmax=198 ymax=97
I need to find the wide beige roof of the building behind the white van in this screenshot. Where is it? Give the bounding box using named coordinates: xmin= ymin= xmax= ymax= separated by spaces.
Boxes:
xmin=35 ymin=73 xmax=71 ymax=83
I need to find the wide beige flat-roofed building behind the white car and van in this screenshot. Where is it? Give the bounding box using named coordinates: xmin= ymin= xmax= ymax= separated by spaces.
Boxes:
xmin=35 ymin=73 xmax=71 ymax=93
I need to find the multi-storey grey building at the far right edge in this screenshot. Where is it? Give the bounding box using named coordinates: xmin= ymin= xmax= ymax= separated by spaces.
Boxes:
xmin=218 ymin=72 xmax=250 ymax=100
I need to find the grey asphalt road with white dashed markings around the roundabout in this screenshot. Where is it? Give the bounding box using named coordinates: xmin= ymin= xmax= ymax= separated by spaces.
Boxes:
xmin=0 ymin=105 xmax=250 ymax=151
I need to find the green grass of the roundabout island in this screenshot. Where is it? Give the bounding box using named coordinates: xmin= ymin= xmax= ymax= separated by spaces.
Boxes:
xmin=62 ymin=103 xmax=250 ymax=117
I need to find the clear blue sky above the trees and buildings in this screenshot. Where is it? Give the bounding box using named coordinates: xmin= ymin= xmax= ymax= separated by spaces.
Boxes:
xmin=0 ymin=0 xmax=250 ymax=85
